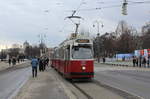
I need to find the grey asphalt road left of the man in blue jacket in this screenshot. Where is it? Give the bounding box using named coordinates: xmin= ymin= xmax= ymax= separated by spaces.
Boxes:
xmin=0 ymin=67 xmax=31 ymax=99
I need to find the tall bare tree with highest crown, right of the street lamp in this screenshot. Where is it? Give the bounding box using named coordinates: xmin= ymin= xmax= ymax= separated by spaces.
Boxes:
xmin=116 ymin=21 xmax=140 ymax=53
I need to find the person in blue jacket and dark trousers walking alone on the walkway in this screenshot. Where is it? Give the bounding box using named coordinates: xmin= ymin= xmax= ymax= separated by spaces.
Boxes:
xmin=31 ymin=57 xmax=38 ymax=78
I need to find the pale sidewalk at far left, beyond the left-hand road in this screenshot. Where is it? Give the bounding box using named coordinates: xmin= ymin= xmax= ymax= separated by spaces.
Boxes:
xmin=0 ymin=61 xmax=29 ymax=71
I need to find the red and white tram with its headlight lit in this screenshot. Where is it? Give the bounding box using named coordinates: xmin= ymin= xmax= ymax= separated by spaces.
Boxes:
xmin=51 ymin=34 xmax=94 ymax=79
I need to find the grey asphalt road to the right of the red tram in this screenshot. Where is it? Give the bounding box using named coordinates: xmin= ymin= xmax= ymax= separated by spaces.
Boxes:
xmin=95 ymin=64 xmax=150 ymax=99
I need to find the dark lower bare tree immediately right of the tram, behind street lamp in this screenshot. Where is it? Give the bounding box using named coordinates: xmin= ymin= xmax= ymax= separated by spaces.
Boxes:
xmin=94 ymin=32 xmax=116 ymax=57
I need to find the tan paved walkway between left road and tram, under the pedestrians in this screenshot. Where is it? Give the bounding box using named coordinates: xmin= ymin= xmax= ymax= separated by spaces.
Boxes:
xmin=14 ymin=67 xmax=69 ymax=99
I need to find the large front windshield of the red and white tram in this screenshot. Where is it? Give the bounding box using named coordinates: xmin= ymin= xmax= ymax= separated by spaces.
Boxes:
xmin=72 ymin=46 xmax=93 ymax=59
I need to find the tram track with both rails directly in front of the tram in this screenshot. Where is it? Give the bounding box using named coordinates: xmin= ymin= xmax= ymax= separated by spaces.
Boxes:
xmin=71 ymin=79 xmax=142 ymax=99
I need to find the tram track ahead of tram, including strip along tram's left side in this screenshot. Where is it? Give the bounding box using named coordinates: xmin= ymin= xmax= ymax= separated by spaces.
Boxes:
xmin=53 ymin=67 xmax=142 ymax=99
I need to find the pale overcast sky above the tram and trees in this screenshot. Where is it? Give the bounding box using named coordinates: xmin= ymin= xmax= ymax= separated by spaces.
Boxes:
xmin=0 ymin=0 xmax=150 ymax=47
